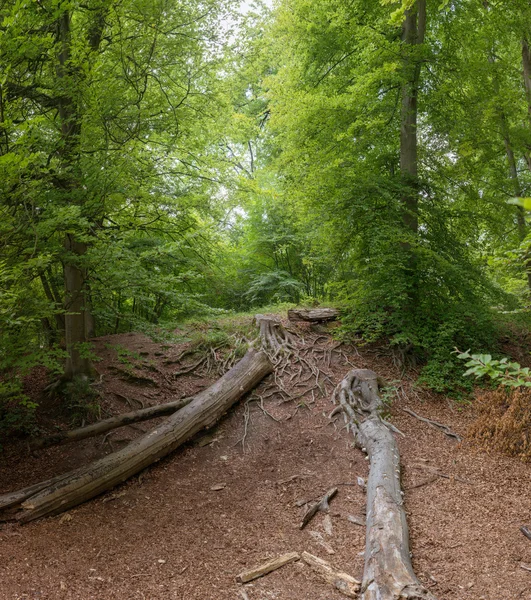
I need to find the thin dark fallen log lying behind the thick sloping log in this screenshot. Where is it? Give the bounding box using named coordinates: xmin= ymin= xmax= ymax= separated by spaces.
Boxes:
xmin=30 ymin=398 xmax=193 ymax=450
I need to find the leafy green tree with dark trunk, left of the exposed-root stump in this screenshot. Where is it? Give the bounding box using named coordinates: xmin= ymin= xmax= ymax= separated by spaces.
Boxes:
xmin=0 ymin=0 xmax=233 ymax=379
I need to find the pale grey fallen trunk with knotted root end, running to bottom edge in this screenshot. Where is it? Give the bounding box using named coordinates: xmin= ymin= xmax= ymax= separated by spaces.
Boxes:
xmin=333 ymin=369 xmax=435 ymax=600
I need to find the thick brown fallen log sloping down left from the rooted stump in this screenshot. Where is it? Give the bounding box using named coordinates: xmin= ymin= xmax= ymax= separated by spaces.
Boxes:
xmin=0 ymin=350 xmax=273 ymax=523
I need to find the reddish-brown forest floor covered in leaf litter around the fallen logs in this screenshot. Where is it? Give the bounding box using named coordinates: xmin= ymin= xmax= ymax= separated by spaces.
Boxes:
xmin=0 ymin=316 xmax=531 ymax=600
